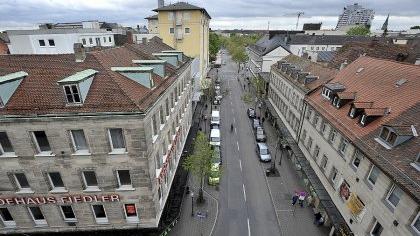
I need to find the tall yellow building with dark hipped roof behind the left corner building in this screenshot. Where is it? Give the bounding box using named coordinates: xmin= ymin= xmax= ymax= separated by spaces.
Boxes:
xmin=154 ymin=2 xmax=211 ymax=78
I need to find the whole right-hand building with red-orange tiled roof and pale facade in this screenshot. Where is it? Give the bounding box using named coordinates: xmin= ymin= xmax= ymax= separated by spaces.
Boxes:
xmin=299 ymin=56 xmax=420 ymax=235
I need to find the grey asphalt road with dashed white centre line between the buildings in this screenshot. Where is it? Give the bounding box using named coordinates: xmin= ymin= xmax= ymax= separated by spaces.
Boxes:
xmin=213 ymin=50 xmax=280 ymax=236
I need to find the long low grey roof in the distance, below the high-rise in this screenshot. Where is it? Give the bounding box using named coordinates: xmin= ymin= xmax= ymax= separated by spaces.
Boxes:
xmin=288 ymin=35 xmax=387 ymax=45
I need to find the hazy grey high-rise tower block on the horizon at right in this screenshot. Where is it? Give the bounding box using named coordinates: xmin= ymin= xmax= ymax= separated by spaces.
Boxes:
xmin=336 ymin=3 xmax=375 ymax=30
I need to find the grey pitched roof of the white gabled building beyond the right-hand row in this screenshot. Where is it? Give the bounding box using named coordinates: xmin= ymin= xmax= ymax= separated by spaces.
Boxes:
xmin=249 ymin=34 xmax=290 ymax=56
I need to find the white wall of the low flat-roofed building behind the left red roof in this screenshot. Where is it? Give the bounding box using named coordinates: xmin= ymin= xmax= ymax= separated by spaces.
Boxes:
xmin=8 ymin=33 xmax=115 ymax=54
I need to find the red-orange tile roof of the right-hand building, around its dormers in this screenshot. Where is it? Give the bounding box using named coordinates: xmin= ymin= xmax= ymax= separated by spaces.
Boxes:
xmin=308 ymin=56 xmax=420 ymax=201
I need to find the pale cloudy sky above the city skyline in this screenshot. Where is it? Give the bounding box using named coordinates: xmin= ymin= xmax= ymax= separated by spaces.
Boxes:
xmin=0 ymin=0 xmax=420 ymax=30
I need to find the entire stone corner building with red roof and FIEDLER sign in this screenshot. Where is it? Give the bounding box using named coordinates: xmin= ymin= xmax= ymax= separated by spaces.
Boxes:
xmin=0 ymin=40 xmax=193 ymax=233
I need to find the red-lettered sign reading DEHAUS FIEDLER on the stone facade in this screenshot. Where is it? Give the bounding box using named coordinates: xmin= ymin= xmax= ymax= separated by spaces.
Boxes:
xmin=0 ymin=194 xmax=120 ymax=206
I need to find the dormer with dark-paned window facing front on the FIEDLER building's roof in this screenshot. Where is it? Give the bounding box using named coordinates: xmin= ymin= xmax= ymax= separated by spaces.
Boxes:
xmin=57 ymin=69 xmax=98 ymax=105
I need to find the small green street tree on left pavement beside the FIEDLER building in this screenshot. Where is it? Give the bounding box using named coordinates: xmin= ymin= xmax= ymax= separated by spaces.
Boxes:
xmin=183 ymin=131 xmax=213 ymax=202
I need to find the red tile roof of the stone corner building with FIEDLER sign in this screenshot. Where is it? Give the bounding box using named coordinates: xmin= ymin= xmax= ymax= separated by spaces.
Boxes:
xmin=0 ymin=42 xmax=190 ymax=116
